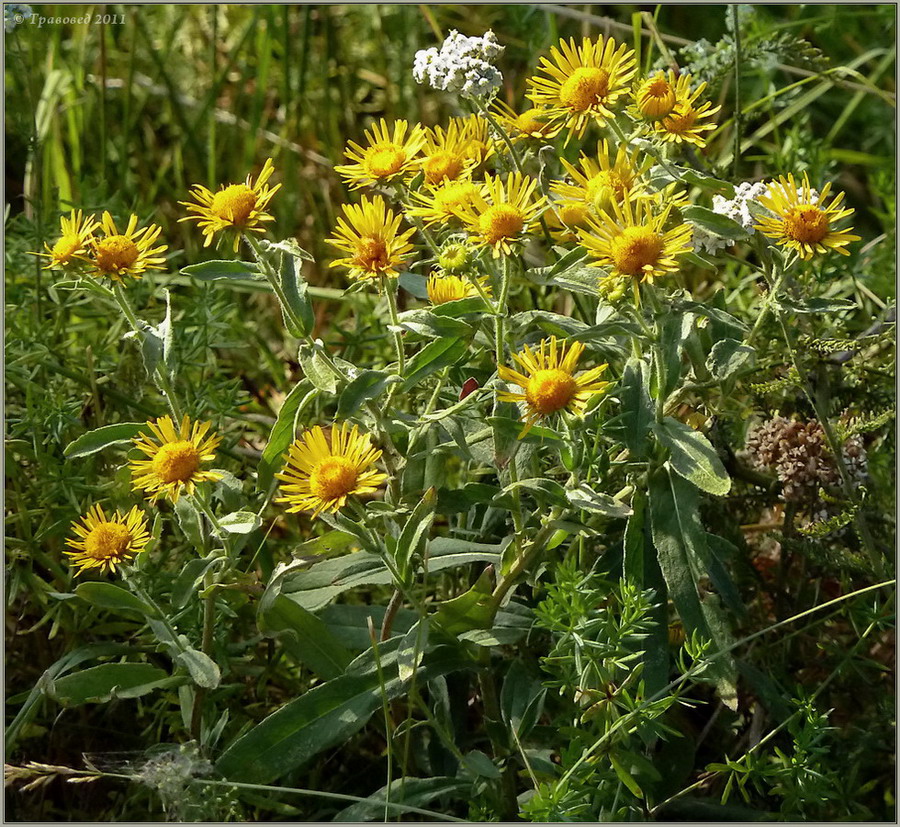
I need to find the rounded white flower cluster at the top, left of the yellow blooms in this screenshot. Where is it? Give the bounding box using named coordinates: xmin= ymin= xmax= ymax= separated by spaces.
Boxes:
xmin=413 ymin=29 xmax=503 ymax=98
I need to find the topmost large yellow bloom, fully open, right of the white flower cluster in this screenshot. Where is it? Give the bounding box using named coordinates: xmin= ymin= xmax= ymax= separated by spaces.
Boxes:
xmin=526 ymin=36 xmax=636 ymax=137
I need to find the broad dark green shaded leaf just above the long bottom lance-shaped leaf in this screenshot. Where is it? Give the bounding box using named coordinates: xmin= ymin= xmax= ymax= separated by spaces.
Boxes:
xmin=257 ymin=595 xmax=353 ymax=680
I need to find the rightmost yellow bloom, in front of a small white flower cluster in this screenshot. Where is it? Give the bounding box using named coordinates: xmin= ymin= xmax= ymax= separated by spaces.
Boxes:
xmin=754 ymin=172 xmax=860 ymax=260
